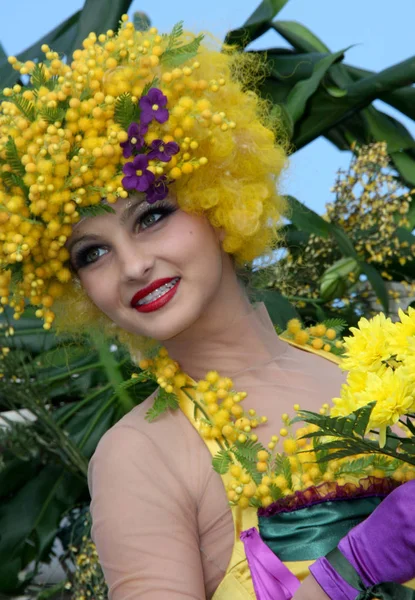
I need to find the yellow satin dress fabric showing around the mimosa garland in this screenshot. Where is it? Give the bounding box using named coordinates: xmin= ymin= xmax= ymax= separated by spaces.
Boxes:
xmin=179 ymin=340 xmax=415 ymax=600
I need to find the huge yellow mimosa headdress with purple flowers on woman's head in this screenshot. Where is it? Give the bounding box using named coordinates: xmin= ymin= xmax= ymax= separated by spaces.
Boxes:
xmin=0 ymin=15 xmax=285 ymax=329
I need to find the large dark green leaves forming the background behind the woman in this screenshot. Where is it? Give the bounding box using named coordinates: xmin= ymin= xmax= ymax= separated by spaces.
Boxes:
xmin=0 ymin=0 xmax=415 ymax=598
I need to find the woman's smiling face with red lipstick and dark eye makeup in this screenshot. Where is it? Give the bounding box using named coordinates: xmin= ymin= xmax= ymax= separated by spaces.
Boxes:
xmin=67 ymin=197 xmax=224 ymax=341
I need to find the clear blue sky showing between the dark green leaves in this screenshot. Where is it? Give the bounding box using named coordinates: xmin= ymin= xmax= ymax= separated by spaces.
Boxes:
xmin=0 ymin=0 xmax=415 ymax=213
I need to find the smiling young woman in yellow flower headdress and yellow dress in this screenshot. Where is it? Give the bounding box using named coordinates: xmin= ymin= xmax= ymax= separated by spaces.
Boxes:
xmin=0 ymin=18 xmax=413 ymax=600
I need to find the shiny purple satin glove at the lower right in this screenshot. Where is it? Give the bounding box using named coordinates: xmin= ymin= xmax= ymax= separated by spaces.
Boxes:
xmin=310 ymin=480 xmax=415 ymax=600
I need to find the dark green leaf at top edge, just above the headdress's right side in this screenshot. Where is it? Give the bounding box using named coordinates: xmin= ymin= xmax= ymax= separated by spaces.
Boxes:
xmin=225 ymin=0 xmax=288 ymax=48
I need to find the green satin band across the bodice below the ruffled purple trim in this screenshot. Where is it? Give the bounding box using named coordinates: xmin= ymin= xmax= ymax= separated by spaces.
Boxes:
xmin=258 ymin=497 xmax=381 ymax=561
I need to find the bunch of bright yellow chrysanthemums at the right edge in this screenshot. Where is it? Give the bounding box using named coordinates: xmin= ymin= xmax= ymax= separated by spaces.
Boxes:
xmin=331 ymin=308 xmax=415 ymax=446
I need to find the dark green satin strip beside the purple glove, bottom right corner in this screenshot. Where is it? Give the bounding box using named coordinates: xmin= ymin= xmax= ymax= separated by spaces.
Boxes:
xmin=326 ymin=548 xmax=415 ymax=600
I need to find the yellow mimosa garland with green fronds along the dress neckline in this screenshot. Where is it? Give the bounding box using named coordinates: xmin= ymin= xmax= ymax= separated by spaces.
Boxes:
xmin=139 ymin=344 xmax=415 ymax=508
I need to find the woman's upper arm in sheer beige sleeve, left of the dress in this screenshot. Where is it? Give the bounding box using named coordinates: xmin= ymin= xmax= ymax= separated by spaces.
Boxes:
xmin=89 ymin=427 xmax=205 ymax=600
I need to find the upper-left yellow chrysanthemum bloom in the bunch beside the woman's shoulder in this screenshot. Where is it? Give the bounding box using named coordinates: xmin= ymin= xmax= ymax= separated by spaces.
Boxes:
xmin=340 ymin=313 xmax=396 ymax=371
